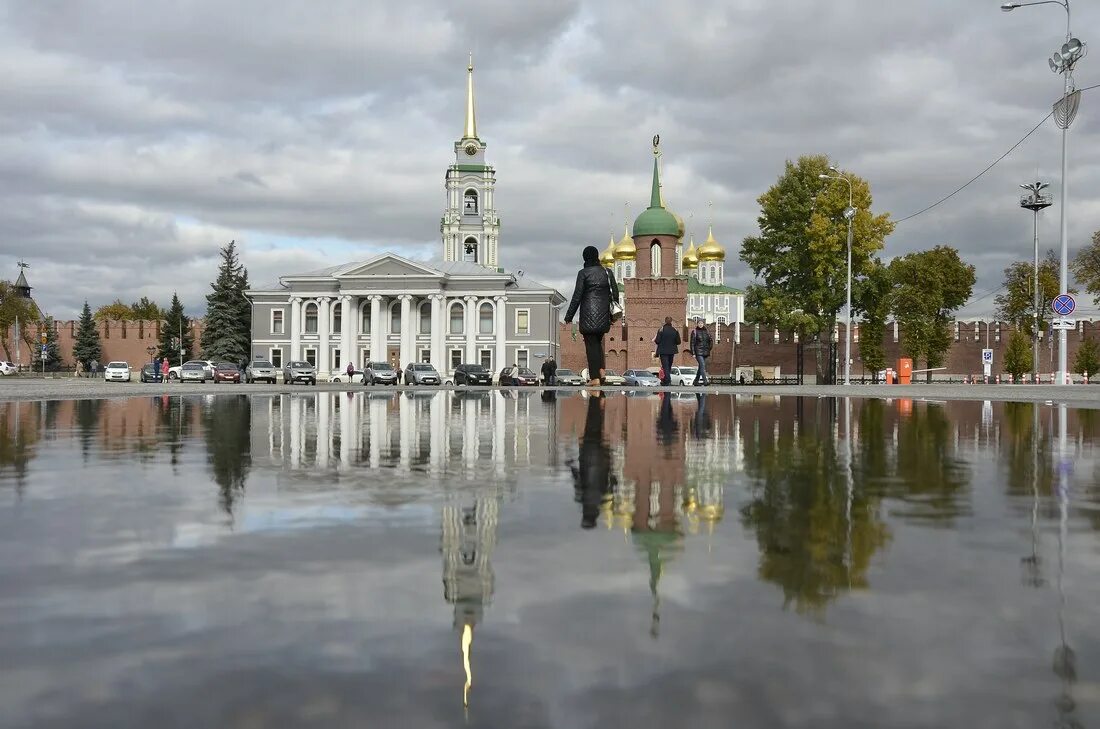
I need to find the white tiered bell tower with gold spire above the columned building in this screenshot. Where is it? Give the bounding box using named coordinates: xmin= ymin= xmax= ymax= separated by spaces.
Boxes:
xmin=439 ymin=54 xmax=501 ymax=268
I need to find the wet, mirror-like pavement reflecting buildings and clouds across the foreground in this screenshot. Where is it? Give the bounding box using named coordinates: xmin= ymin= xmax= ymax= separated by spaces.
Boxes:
xmin=0 ymin=389 xmax=1100 ymax=729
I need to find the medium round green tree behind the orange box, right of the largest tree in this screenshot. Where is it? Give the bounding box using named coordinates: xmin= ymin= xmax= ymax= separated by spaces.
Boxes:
xmin=890 ymin=245 xmax=975 ymax=382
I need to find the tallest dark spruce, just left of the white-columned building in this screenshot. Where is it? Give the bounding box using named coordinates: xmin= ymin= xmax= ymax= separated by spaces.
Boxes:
xmin=201 ymin=241 xmax=252 ymax=362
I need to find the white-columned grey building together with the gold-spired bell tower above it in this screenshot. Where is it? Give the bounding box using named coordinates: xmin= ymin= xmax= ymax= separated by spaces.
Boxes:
xmin=248 ymin=57 xmax=565 ymax=378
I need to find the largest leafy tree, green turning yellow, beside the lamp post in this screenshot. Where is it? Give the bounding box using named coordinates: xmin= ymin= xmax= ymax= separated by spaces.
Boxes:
xmin=740 ymin=155 xmax=894 ymax=377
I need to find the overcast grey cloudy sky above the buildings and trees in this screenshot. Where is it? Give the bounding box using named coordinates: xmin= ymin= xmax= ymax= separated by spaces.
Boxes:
xmin=0 ymin=0 xmax=1100 ymax=319
